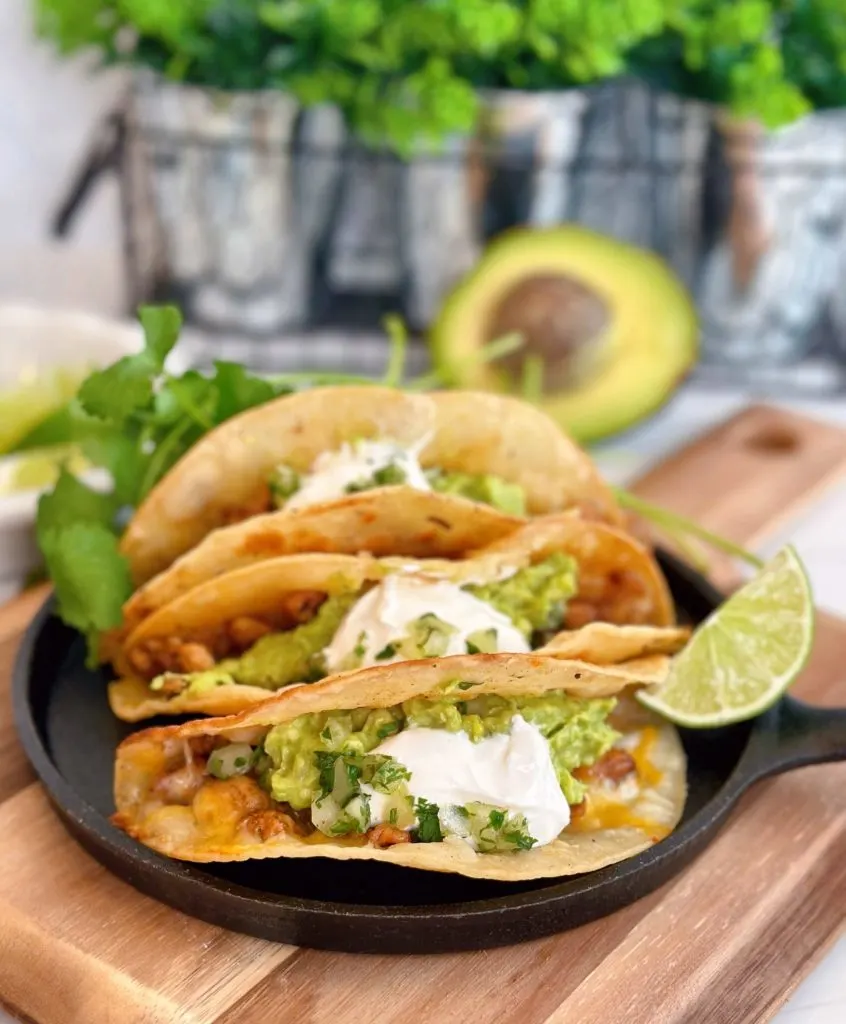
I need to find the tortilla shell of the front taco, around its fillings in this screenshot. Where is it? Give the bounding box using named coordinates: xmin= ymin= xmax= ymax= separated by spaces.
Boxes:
xmin=114 ymin=654 xmax=686 ymax=881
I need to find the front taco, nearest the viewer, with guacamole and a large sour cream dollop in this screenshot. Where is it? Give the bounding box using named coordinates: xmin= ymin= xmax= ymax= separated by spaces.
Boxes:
xmin=113 ymin=654 xmax=685 ymax=881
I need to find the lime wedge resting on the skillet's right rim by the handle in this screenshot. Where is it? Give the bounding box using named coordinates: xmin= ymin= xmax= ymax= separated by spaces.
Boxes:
xmin=637 ymin=546 xmax=814 ymax=729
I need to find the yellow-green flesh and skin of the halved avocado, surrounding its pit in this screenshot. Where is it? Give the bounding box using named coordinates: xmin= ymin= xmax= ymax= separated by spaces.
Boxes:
xmin=429 ymin=224 xmax=699 ymax=442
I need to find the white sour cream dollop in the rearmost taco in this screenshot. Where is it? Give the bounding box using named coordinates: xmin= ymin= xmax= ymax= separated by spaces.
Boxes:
xmin=285 ymin=440 xmax=432 ymax=509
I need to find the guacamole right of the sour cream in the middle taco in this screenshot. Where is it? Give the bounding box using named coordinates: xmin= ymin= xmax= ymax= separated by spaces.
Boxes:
xmin=464 ymin=551 xmax=578 ymax=637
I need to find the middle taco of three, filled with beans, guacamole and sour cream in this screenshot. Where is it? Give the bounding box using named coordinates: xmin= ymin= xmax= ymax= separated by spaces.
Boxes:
xmin=109 ymin=513 xmax=686 ymax=721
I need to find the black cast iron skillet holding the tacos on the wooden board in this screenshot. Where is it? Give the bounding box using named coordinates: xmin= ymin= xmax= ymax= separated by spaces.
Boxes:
xmin=13 ymin=556 xmax=846 ymax=953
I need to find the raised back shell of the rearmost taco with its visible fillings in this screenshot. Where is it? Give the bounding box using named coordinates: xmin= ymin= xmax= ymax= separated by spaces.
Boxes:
xmin=122 ymin=387 xmax=621 ymax=585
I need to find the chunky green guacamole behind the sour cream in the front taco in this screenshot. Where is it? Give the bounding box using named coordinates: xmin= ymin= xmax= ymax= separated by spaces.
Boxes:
xmin=262 ymin=682 xmax=619 ymax=810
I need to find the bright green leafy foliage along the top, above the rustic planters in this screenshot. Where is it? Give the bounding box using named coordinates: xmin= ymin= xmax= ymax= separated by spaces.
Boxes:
xmin=35 ymin=0 xmax=846 ymax=152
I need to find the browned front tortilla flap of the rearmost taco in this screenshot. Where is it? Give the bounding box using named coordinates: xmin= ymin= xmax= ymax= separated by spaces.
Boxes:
xmin=115 ymin=487 xmax=523 ymax=636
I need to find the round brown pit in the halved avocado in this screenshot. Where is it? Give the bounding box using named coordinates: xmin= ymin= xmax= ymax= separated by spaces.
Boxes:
xmin=488 ymin=273 xmax=611 ymax=393
